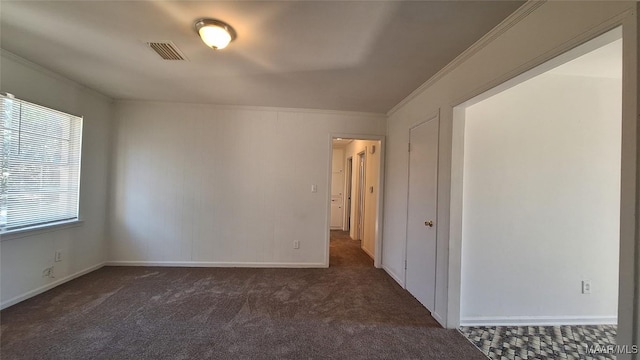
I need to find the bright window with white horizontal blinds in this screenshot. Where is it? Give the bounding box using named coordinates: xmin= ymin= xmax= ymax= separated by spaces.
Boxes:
xmin=0 ymin=94 xmax=82 ymax=232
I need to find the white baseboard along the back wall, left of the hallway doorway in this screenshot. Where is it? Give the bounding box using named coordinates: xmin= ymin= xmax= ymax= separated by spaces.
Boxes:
xmin=105 ymin=261 xmax=327 ymax=268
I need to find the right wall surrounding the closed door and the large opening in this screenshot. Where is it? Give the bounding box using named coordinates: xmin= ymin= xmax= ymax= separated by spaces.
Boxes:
xmin=382 ymin=2 xmax=637 ymax=336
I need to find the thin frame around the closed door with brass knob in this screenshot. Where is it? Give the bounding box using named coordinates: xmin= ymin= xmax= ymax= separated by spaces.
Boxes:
xmin=402 ymin=111 xmax=440 ymax=292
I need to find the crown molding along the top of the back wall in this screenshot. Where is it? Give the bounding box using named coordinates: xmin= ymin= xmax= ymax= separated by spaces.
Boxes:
xmin=115 ymin=99 xmax=387 ymax=120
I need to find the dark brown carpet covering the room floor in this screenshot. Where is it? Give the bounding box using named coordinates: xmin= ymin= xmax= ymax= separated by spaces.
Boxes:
xmin=0 ymin=233 xmax=485 ymax=360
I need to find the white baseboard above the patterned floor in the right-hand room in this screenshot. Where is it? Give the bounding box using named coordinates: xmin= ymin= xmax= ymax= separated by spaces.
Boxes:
xmin=460 ymin=316 xmax=618 ymax=326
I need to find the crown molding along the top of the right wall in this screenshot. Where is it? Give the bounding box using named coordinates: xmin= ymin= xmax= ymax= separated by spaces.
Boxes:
xmin=387 ymin=0 xmax=547 ymax=116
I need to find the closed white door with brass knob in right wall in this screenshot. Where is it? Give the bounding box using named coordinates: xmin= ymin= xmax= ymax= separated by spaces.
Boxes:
xmin=405 ymin=118 xmax=439 ymax=311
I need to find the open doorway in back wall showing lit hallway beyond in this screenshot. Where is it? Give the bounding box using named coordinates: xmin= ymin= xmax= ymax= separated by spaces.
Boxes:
xmin=328 ymin=136 xmax=384 ymax=267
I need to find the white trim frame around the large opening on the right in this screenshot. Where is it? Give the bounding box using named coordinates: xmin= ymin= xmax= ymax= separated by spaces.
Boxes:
xmin=446 ymin=23 xmax=640 ymax=346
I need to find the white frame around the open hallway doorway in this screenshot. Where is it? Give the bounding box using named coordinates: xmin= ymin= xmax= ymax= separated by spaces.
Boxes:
xmin=324 ymin=133 xmax=386 ymax=268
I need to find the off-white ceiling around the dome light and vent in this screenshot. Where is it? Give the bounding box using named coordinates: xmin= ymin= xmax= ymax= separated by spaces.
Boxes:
xmin=0 ymin=0 xmax=523 ymax=113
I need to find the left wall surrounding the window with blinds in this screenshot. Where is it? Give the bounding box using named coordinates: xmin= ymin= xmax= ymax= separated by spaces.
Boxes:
xmin=0 ymin=51 xmax=112 ymax=307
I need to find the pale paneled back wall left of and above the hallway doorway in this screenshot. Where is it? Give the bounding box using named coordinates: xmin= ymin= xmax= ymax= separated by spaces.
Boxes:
xmin=109 ymin=101 xmax=386 ymax=267
